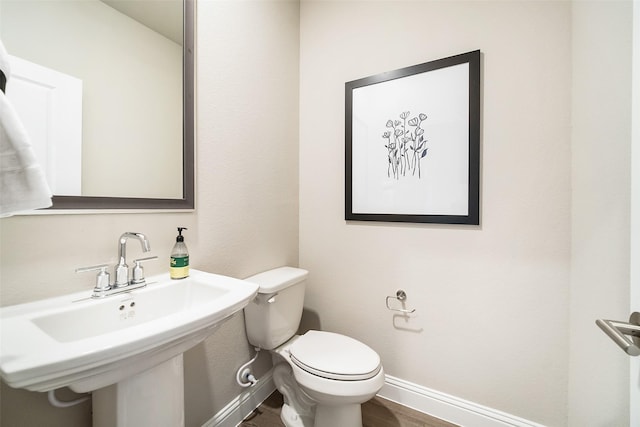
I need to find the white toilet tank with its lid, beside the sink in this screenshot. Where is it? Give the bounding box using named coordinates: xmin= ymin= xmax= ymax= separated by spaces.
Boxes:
xmin=244 ymin=267 xmax=309 ymax=350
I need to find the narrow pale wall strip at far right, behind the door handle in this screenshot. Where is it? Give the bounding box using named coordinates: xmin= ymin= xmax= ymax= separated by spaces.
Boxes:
xmin=568 ymin=1 xmax=640 ymax=427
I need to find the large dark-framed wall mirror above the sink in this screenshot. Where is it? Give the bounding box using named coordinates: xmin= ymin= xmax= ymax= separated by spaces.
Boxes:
xmin=0 ymin=0 xmax=195 ymax=210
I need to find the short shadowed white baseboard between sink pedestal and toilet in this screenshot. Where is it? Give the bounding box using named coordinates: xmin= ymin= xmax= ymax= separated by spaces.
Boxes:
xmin=202 ymin=370 xmax=276 ymax=427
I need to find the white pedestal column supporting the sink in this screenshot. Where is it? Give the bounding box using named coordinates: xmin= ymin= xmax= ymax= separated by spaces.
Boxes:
xmin=93 ymin=354 xmax=184 ymax=427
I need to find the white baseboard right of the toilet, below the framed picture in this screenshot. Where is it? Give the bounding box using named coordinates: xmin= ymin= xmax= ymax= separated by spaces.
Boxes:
xmin=378 ymin=375 xmax=544 ymax=427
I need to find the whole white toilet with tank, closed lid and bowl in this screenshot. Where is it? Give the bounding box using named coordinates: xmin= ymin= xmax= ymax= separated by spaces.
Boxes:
xmin=244 ymin=267 xmax=384 ymax=427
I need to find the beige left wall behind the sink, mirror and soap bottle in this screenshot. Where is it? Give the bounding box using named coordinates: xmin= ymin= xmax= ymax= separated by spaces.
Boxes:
xmin=0 ymin=0 xmax=299 ymax=427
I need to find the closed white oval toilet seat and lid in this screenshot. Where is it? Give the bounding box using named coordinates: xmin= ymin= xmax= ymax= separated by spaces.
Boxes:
xmin=289 ymin=330 xmax=381 ymax=381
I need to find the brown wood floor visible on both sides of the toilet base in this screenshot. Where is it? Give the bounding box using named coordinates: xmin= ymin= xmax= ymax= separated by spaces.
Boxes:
xmin=240 ymin=391 xmax=458 ymax=427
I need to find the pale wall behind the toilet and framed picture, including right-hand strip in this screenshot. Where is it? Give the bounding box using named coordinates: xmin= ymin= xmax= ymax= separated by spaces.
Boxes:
xmin=300 ymin=0 xmax=631 ymax=426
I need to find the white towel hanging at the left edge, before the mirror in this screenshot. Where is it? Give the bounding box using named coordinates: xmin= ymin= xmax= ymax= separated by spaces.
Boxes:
xmin=0 ymin=41 xmax=51 ymax=218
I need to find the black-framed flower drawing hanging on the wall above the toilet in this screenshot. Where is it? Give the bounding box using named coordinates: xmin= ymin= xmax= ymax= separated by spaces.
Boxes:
xmin=345 ymin=50 xmax=480 ymax=225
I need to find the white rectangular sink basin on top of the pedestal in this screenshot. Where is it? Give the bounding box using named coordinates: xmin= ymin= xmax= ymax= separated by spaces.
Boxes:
xmin=0 ymin=269 xmax=258 ymax=392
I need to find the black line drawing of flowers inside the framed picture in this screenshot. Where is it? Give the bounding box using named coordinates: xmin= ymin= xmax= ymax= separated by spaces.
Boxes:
xmin=382 ymin=111 xmax=429 ymax=179
